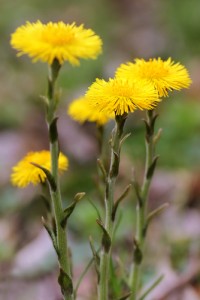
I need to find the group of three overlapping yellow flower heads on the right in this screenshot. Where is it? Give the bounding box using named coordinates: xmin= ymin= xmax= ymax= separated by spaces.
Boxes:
xmin=68 ymin=58 xmax=191 ymax=125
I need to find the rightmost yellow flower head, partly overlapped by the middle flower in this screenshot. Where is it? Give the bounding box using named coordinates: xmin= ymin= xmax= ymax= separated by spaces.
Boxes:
xmin=116 ymin=58 xmax=191 ymax=97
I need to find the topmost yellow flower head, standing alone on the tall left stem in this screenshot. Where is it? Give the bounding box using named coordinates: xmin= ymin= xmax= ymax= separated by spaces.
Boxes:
xmin=11 ymin=21 xmax=102 ymax=65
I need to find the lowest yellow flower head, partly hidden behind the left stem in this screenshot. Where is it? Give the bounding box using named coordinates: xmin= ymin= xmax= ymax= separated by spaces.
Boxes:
xmin=11 ymin=150 xmax=68 ymax=188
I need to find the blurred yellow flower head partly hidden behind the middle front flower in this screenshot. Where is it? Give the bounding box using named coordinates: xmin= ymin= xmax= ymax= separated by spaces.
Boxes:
xmin=68 ymin=97 xmax=114 ymax=125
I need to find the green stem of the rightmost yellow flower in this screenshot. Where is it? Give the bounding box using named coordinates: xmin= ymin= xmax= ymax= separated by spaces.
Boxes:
xmin=129 ymin=111 xmax=155 ymax=300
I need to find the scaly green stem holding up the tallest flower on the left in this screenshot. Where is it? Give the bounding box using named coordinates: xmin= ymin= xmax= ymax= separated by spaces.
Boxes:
xmin=47 ymin=60 xmax=73 ymax=300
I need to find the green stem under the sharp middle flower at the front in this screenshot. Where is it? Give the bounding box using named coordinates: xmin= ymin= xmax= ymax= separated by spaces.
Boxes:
xmin=98 ymin=115 xmax=126 ymax=300
